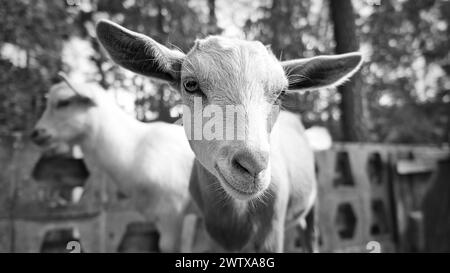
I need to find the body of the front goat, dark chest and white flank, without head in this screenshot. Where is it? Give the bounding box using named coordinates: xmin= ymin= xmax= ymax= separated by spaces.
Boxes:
xmin=190 ymin=112 xmax=316 ymax=252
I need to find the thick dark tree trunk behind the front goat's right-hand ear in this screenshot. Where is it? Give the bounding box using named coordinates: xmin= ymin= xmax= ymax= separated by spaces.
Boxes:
xmin=329 ymin=0 xmax=368 ymax=141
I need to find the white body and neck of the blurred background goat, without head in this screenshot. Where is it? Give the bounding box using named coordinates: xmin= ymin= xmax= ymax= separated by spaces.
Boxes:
xmin=80 ymin=93 xmax=194 ymax=251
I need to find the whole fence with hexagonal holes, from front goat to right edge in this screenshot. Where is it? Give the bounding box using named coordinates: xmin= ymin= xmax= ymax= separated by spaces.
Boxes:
xmin=287 ymin=143 xmax=450 ymax=252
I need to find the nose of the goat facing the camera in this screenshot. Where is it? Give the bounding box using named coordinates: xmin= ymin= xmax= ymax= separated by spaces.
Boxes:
xmin=231 ymin=149 xmax=269 ymax=177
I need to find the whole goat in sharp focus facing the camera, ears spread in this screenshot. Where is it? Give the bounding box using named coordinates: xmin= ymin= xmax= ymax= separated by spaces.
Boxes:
xmin=96 ymin=20 xmax=362 ymax=252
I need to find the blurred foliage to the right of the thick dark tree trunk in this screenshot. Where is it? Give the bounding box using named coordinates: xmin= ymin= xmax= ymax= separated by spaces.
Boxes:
xmin=359 ymin=0 xmax=450 ymax=143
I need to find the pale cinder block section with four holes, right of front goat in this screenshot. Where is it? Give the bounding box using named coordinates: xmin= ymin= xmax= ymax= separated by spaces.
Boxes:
xmin=316 ymin=143 xmax=395 ymax=252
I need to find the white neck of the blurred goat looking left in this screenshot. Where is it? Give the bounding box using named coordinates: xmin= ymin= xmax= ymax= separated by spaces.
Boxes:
xmin=81 ymin=98 xmax=145 ymax=188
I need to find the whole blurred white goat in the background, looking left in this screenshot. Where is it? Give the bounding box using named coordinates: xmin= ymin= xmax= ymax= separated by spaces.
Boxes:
xmin=32 ymin=75 xmax=194 ymax=252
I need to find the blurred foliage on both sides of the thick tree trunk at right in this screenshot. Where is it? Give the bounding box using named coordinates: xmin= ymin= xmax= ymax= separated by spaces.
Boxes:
xmin=244 ymin=0 xmax=450 ymax=143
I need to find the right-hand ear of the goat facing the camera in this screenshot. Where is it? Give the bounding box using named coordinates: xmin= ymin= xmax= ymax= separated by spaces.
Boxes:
xmin=281 ymin=52 xmax=362 ymax=91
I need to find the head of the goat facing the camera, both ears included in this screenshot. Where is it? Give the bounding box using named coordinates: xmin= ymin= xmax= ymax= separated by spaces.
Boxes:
xmin=97 ymin=18 xmax=362 ymax=200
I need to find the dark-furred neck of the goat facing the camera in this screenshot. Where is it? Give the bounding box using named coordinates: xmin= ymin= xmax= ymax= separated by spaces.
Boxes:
xmin=190 ymin=161 xmax=276 ymax=250
